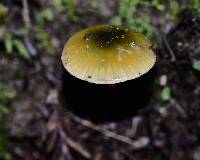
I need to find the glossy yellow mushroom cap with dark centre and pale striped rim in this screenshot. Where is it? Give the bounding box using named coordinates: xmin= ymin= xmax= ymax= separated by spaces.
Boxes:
xmin=61 ymin=25 xmax=156 ymax=84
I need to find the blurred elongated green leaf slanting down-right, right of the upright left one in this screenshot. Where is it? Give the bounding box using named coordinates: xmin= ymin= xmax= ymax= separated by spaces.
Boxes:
xmin=13 ymin=39 xmax=30 ymax=59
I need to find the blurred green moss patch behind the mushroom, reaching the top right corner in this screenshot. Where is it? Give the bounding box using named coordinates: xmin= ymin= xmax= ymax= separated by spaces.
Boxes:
xmin=111 ymin=0 xmax=200 ymax=42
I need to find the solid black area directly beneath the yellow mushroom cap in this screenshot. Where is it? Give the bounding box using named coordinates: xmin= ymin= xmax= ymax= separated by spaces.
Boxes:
xmin=61 ymin=68 xmax=156 ymax=122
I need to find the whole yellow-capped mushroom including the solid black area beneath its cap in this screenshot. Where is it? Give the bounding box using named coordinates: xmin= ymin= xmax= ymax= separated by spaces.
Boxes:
xmin=61 ymin=25 xmax=156 ymax=122
